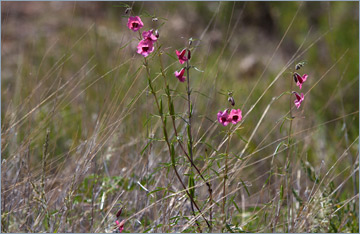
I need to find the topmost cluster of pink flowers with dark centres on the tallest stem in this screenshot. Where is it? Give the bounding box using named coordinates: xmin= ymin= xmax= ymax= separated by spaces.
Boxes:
xmin=127 ymin=16 xmax=159 ymax=57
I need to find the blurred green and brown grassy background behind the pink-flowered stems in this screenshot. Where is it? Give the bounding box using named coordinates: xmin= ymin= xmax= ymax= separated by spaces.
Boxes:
xmin=1 ymin=2 xmax=359 ymax=232
